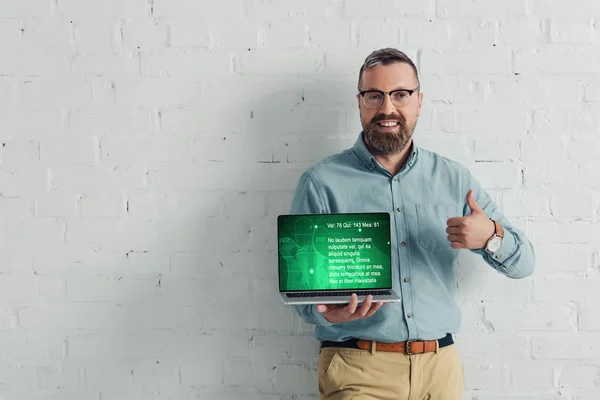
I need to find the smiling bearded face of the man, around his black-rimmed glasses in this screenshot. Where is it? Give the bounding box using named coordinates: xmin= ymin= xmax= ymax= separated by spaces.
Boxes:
xmin=357 ymin=63 xmax=423 ymax=154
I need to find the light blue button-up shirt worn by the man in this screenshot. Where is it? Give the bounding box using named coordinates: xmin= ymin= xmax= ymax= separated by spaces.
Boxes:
xmin=291 ymin=134 xmax=535 ymax=342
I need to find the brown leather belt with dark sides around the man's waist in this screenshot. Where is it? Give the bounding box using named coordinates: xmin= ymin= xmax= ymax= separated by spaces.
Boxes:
xmin=321 ymin=334 xmax=454 ymax=355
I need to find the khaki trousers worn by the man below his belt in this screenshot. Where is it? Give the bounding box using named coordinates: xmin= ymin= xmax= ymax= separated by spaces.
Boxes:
xmin=319 ymin=345 xmax=464 ymax=400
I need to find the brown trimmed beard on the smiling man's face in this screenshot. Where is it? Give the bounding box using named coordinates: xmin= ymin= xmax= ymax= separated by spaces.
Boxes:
xmin=363 ymin=114 xmax=417 ymax=154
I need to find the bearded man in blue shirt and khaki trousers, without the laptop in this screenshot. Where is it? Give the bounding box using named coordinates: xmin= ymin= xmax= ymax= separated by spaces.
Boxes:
xmin=291 ymin=49 xmax=535 ymax=400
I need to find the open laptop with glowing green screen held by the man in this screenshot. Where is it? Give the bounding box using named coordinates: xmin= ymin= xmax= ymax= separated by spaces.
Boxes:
xmin=277 ymin=212 xmax=400 ymax=305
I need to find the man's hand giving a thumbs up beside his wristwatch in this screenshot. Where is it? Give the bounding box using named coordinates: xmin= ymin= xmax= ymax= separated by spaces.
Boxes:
xmin=446 ymin=189 xmax=495 ymax=249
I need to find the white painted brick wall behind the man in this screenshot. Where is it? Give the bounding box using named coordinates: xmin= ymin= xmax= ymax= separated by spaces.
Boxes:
xmin=0 ymin=0 xmax=600 ymax=400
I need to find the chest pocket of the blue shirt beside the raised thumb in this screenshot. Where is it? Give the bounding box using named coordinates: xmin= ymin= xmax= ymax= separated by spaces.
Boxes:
xmin=416 ymin=204 xmax=462 ymax=251
